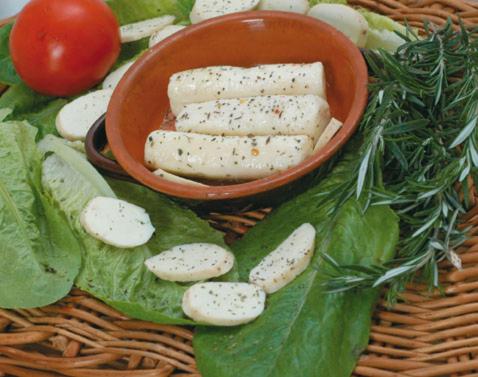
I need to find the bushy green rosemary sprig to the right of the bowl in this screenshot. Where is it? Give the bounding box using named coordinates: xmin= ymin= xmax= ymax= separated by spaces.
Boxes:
xmin=324 ymin=22 xmax=478 ymax=301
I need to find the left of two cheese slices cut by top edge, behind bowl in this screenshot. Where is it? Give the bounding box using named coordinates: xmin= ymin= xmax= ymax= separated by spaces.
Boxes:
xmin=189 ymin=0 xmax=259 ymax=24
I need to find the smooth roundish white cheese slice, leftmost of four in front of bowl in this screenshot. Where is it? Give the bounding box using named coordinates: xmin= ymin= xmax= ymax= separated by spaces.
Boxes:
xmin=80 ymin=196 xmax=154 ymax=248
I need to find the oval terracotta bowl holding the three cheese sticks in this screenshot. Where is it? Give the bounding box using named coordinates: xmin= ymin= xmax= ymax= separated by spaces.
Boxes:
xmin=102 ymin=11 xmax=368 ymax=206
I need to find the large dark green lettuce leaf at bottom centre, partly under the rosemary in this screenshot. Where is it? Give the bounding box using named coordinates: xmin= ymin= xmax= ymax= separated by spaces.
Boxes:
xmin=194 ymin=152 xmax=398 ymax=377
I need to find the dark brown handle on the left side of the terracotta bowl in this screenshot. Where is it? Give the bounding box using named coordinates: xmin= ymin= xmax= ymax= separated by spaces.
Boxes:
xmin=85 ymin=114 xmax=138 ymax=183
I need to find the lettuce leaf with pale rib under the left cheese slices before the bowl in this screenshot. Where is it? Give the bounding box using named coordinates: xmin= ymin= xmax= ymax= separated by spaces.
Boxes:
xmin=43 ymin=147 xmax=237 ymax=324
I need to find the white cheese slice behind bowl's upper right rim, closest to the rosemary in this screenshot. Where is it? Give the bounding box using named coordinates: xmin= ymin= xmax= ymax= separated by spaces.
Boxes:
xmin=308 ymin=4 xmax=368 ymax=47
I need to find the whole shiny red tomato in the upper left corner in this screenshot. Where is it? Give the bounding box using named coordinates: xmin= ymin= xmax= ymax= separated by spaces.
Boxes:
xmin=10 ymin=0 xmax=121 ymax=96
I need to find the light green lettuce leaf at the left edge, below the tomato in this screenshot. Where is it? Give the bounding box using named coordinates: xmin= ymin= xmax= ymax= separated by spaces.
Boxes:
xmin=0 ymin=122 xmax=81 ymax=308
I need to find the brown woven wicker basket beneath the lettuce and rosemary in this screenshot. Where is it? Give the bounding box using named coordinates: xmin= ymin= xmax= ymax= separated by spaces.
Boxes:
xmin=0 ymin=0 xmax=478 ymax=377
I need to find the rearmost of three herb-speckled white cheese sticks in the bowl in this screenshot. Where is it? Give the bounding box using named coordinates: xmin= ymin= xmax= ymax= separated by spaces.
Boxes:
xmin=168 ymin=63 xmax=326 ymax=115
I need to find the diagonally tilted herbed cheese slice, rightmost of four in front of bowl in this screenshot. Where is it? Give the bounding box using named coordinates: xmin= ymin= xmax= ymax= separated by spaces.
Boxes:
xmin=249 ymin=224 xmax=316 ymax=294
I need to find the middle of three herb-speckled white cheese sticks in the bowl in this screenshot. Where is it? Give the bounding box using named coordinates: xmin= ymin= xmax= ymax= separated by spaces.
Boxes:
xmin=176 ymin=94 xmax=330 ymax=140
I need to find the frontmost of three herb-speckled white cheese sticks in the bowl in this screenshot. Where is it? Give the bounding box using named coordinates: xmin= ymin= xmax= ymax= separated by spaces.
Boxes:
xmin=145 ymin=131 xmax=313 ymax=180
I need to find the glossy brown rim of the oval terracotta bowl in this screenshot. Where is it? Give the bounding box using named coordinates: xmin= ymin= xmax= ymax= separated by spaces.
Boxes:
xmin=106 ymin=11 xmax=368 ymax=201
